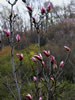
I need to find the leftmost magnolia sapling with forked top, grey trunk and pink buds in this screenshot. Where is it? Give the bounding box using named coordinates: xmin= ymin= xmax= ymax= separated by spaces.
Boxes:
xmin=3 ymin=0 xmax=21 ymax=100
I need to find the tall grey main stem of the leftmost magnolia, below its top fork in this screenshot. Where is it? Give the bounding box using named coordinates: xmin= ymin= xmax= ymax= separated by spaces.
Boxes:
xmin=10 ymin=5 xmax=21 ymax=100
